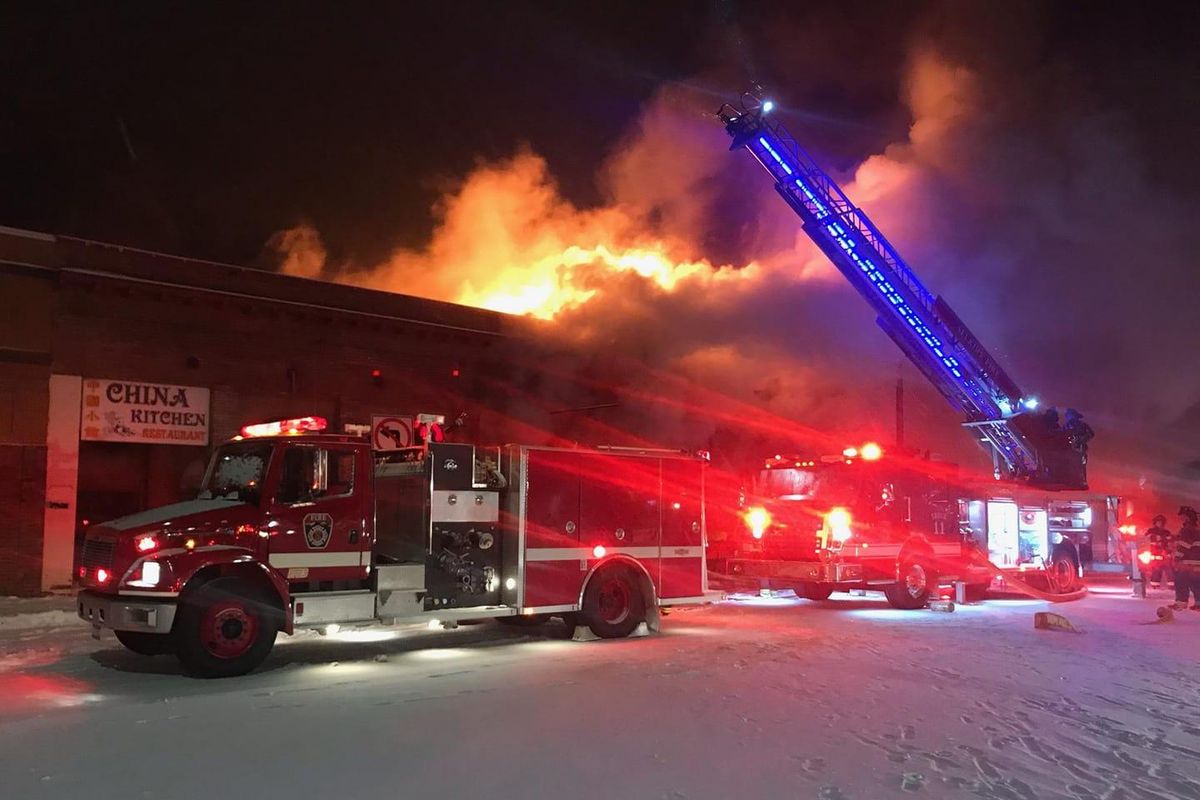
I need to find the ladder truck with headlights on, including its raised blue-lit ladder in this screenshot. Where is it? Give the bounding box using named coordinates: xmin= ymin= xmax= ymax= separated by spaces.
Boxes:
xmin=718 ymin=91 xmax=1116 ymax=607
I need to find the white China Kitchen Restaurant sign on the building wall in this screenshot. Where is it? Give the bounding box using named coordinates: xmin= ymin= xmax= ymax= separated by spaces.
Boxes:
xmin=79 ymin=378 xmax=209 ymax=445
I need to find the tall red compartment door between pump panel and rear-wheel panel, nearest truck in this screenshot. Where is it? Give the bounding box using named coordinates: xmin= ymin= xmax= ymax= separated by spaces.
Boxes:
xmin=518 ymin=450 xmax=584 ymax=608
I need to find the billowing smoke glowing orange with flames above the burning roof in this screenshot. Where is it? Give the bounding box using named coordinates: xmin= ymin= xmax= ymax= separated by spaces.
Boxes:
xmin=272 ymin=34 xmax=1200 ymax=510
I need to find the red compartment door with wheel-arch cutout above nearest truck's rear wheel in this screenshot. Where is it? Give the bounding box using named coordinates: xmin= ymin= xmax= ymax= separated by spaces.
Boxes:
xmin=580 ymin=453 xmax=662 ymax=595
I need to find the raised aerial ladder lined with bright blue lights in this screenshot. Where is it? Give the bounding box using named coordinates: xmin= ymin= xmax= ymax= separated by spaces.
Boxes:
xmin=718 ymin=92 xmax=1091 ymax=488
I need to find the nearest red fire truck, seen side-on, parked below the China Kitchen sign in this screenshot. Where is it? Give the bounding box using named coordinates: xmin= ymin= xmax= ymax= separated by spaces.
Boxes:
xmin=78 ymin=417 xmax=707 ymax=676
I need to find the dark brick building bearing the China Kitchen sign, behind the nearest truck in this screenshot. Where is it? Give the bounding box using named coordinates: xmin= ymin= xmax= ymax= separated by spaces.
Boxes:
xmin=0 ymin=228 xmax=559 ymax=595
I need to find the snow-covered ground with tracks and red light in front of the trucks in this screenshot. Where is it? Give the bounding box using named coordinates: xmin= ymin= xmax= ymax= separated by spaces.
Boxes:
xmin=0 ymin=583 xmax=1200 ymax=800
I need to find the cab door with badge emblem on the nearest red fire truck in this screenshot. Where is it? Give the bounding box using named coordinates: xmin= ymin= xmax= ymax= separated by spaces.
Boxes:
xmin=268 ymin=441 xmax=371 ymax=582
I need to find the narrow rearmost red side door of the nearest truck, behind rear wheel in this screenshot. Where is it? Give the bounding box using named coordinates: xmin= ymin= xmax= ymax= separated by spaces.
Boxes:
xmin=660 ymin=458 xmax=706 ymax=597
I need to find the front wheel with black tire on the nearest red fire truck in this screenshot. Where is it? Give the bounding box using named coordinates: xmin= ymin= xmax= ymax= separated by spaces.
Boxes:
xmin=173 ymin=578 xmax=283 ymax=678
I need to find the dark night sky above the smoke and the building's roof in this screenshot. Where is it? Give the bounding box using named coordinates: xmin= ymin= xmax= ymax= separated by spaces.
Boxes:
xmin=0 ymin=0 xmax=1200 ymax=263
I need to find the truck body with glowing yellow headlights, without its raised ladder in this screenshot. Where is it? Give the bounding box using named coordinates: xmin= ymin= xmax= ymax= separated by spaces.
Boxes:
xmin=710 ymin=443 xmax=1117 ymax=608
